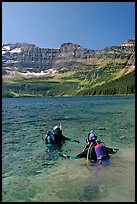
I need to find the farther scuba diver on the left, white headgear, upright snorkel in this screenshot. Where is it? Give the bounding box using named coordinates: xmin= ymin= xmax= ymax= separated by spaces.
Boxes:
xmin=44 ymin=126 xmax=79 ymax=146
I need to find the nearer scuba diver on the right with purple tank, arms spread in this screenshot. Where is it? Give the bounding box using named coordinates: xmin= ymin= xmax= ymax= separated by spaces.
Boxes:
xmin=64 ymin=130 xmax=118 ymax=163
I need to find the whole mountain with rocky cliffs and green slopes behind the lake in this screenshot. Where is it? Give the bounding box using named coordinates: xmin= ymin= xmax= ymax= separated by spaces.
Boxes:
xmin=2 ymin=39 xmax=135 ymax=96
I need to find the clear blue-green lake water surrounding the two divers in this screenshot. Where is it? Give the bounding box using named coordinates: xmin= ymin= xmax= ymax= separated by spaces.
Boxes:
xmin=2 ymin=96 xmax=135 ymax=202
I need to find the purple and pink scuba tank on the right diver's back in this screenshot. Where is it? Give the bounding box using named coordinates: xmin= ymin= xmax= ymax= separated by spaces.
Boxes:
xmin=94 ymin=143 xmax=107 ymax=159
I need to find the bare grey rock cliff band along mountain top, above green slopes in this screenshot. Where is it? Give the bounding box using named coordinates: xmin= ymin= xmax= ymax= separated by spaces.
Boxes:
xmin=2 ymin=39 xmax=135 ymax=72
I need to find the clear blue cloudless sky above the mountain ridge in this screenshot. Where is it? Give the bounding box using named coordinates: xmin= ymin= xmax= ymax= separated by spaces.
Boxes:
xmin=2 ymin=2 xmax=135 ymax=50
